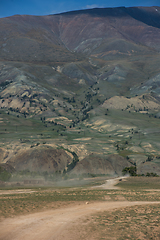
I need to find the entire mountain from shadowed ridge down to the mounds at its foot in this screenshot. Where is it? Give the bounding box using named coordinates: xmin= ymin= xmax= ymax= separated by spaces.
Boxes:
xmin=0 ymin=7 xmax=160 ymax=178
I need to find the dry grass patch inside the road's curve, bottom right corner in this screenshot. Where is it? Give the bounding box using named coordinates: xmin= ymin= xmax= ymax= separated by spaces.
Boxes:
xmin=73 ymin=204 xmax=160 ymax=240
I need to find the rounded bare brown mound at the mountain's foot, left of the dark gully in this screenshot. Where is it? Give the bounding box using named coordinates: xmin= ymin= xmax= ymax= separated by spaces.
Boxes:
xmin=7 ymin=147 xmax=71 ymax=173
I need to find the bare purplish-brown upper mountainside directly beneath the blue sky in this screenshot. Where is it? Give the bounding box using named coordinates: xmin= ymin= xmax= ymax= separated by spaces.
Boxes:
xmin=0 ymin=7 xmax=160 ymax=63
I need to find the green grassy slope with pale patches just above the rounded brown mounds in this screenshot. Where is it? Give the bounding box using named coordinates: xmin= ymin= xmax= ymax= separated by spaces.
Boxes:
xmin=0 ymin=98 xmax=160 ymax=173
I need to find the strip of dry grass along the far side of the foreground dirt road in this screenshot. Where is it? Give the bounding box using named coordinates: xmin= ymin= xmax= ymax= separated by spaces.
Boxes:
xmin=0 ymin=178 xmax=160 ymax=217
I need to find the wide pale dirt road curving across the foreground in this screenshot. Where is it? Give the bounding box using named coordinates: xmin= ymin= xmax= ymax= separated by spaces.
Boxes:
xmin=0 ymin=201 xmax=160 ymax=240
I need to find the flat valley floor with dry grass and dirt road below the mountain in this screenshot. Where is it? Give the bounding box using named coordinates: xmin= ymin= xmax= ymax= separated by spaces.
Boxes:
xmin=0 ymin=177 xmax=160 ymax=240
